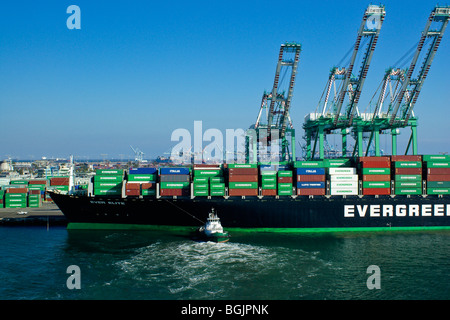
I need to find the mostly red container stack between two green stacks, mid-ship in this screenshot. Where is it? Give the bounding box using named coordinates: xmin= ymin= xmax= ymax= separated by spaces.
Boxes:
xmin=228 ymin=163 xmax=258 ymax=196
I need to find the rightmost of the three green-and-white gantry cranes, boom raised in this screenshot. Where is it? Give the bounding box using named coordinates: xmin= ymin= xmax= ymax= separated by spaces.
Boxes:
xmin=356 ymin=6 xmax=450 ymax=155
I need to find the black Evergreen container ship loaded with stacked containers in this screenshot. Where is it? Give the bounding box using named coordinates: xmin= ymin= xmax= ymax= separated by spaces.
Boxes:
xmin=50 ymin=155 xmax=450 ymax=232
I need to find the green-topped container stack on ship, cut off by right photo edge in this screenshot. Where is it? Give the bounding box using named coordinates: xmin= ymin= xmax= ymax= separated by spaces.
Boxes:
xmin=423 ymin=155 xmax=450 ymax=194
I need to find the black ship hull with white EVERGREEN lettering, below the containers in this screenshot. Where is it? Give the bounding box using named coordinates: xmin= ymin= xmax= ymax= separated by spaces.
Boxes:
xmin=51 ymin=193 xmax=450 ymax=232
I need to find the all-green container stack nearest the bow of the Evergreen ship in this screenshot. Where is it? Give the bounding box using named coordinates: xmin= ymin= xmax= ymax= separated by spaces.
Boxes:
xmin=94 ymin=169 xmax=124 ymax=196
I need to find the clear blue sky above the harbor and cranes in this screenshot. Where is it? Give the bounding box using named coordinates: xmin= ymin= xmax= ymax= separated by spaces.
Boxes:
xmin=0 ymin=0 xmax=450 ymax=159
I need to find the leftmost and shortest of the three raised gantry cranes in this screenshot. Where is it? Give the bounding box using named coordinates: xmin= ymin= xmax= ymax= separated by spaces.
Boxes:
xmin=250 ymin=42 xmax=301 ymax=162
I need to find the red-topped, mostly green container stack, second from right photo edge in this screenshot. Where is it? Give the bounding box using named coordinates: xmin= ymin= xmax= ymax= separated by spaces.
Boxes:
xmin=391 ymin=155 xmax=422 ymax=195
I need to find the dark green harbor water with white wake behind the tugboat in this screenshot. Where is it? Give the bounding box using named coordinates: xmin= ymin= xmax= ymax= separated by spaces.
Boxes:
xmin=0 ymin=226 xmax=450 ymax=300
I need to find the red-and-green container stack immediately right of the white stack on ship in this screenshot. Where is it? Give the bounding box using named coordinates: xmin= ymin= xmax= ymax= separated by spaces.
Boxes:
xmin=358 ymin=157 xmax=391 ymax=195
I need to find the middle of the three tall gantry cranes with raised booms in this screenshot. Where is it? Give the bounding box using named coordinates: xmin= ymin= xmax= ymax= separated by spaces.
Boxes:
xmin=303 ymin=5 xmax=386 ymax=159
